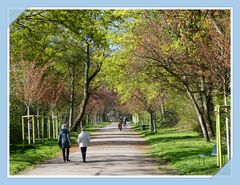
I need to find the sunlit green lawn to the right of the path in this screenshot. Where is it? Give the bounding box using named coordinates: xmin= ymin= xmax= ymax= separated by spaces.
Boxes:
xmin=136 ymin=125 xmax=224 ymax=175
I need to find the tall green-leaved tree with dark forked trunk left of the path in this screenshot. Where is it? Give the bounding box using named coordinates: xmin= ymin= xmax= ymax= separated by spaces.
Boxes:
xmin=12 ymin=10 xmax=127 ymax=130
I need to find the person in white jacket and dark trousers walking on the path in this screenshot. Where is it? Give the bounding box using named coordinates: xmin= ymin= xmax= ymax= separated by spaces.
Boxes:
xmin=77 ymin=128 xmax=91 ymax=162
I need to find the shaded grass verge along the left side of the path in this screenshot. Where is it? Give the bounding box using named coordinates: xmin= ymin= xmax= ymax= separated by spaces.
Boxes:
xmin=9 ymin=122 xmax=109 ymax=175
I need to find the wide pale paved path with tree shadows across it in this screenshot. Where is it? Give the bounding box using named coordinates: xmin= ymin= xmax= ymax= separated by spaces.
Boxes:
xmin=19 ymin=123 xmax=174 ymax=176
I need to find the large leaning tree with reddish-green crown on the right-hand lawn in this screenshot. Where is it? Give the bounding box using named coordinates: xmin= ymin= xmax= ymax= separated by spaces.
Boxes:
xmin=128 ymin=10 xmax=229 ymax=141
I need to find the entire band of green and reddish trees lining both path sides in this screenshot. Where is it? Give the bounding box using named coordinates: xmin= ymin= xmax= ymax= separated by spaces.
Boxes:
xmin=9 ymin=10 xmax=231 ymax=141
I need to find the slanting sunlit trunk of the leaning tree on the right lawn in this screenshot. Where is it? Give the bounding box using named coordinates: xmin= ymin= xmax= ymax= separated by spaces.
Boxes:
xmin=185 ymin=84 xmax=210 ymax=142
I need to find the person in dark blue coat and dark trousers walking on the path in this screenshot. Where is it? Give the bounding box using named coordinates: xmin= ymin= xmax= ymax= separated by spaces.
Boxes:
xmin=58 ymin=124 xmax=71 ymax=162
